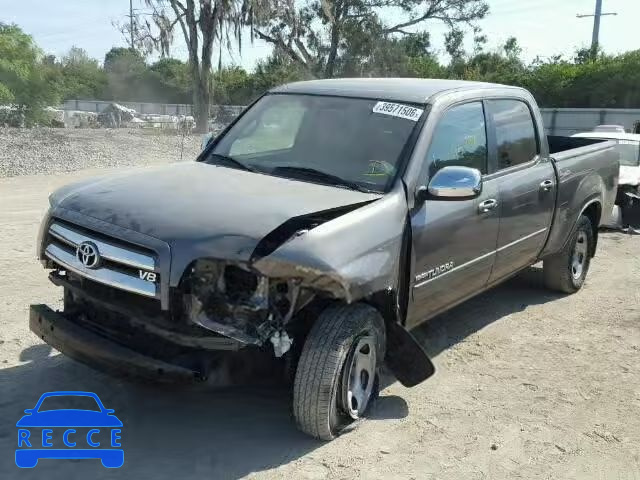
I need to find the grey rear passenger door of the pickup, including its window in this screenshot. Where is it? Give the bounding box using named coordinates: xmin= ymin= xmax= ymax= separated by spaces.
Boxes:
xmin=485 ymin=99 xmax=557 ymax=283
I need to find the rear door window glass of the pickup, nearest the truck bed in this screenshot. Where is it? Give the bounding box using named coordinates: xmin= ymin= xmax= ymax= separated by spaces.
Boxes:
xmin=487 ymin=100 xmax=538 ymax=170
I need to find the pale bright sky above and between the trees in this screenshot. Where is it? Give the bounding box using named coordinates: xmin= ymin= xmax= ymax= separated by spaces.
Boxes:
xmin=0 ymin=0 xmax=640 ymax=70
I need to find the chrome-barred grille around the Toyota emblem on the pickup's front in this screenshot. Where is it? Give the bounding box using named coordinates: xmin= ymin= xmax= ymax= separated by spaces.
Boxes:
xmin=44 ymin=222 xmax=158 ymax=297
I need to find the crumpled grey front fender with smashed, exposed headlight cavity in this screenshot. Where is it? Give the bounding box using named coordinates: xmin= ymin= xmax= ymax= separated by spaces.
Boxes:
xmin=181 ymin=186 xmax=407 ymax=352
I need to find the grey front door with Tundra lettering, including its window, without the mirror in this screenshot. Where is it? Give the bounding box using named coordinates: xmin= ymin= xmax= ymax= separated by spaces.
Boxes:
xmin=407 ymin=101 xmax=500 ymax=327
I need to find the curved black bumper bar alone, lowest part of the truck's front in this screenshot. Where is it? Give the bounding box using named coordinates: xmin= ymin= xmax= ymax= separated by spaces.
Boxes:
xmin=29 ymin=305 xmax=204 ymax=383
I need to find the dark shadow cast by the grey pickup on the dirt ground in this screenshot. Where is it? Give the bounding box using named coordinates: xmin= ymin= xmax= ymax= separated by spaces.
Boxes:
xmin=0 ymin=269 xmax=557 ymax=479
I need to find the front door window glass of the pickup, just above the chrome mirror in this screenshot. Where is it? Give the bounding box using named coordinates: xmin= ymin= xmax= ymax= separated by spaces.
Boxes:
xmin=427 ymin=102 xmax=487 ymax=175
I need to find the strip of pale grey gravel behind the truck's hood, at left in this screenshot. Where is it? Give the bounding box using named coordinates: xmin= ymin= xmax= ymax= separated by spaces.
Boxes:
xmin=0 ymin=128 xmax=202 ymax=177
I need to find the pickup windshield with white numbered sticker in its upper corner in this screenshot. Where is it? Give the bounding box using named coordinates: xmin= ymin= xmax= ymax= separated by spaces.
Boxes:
xmin=203 ymin=94 xmax=423 ymax=191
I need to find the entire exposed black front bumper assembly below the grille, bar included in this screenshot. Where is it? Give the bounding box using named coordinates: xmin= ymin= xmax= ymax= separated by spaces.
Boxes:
xmin=29 ymin=272 xmax=250 ymax=383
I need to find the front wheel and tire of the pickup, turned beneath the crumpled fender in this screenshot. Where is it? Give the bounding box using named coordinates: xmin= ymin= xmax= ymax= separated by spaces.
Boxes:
xmin=293 ymin=304 xmax=385 ymax=440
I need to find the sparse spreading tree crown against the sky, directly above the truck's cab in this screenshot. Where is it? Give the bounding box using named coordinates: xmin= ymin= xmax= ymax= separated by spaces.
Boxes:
xmin=254 ymin=0 xmax=489 ymax=78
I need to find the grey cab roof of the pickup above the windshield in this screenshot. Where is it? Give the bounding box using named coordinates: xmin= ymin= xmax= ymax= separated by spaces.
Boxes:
xmin=270 ymin=78 xmax=513 ymax=104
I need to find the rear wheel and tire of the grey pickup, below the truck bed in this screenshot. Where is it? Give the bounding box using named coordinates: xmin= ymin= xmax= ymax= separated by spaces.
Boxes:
xmin=543 ymin=215 xmax=595 ymax=293
